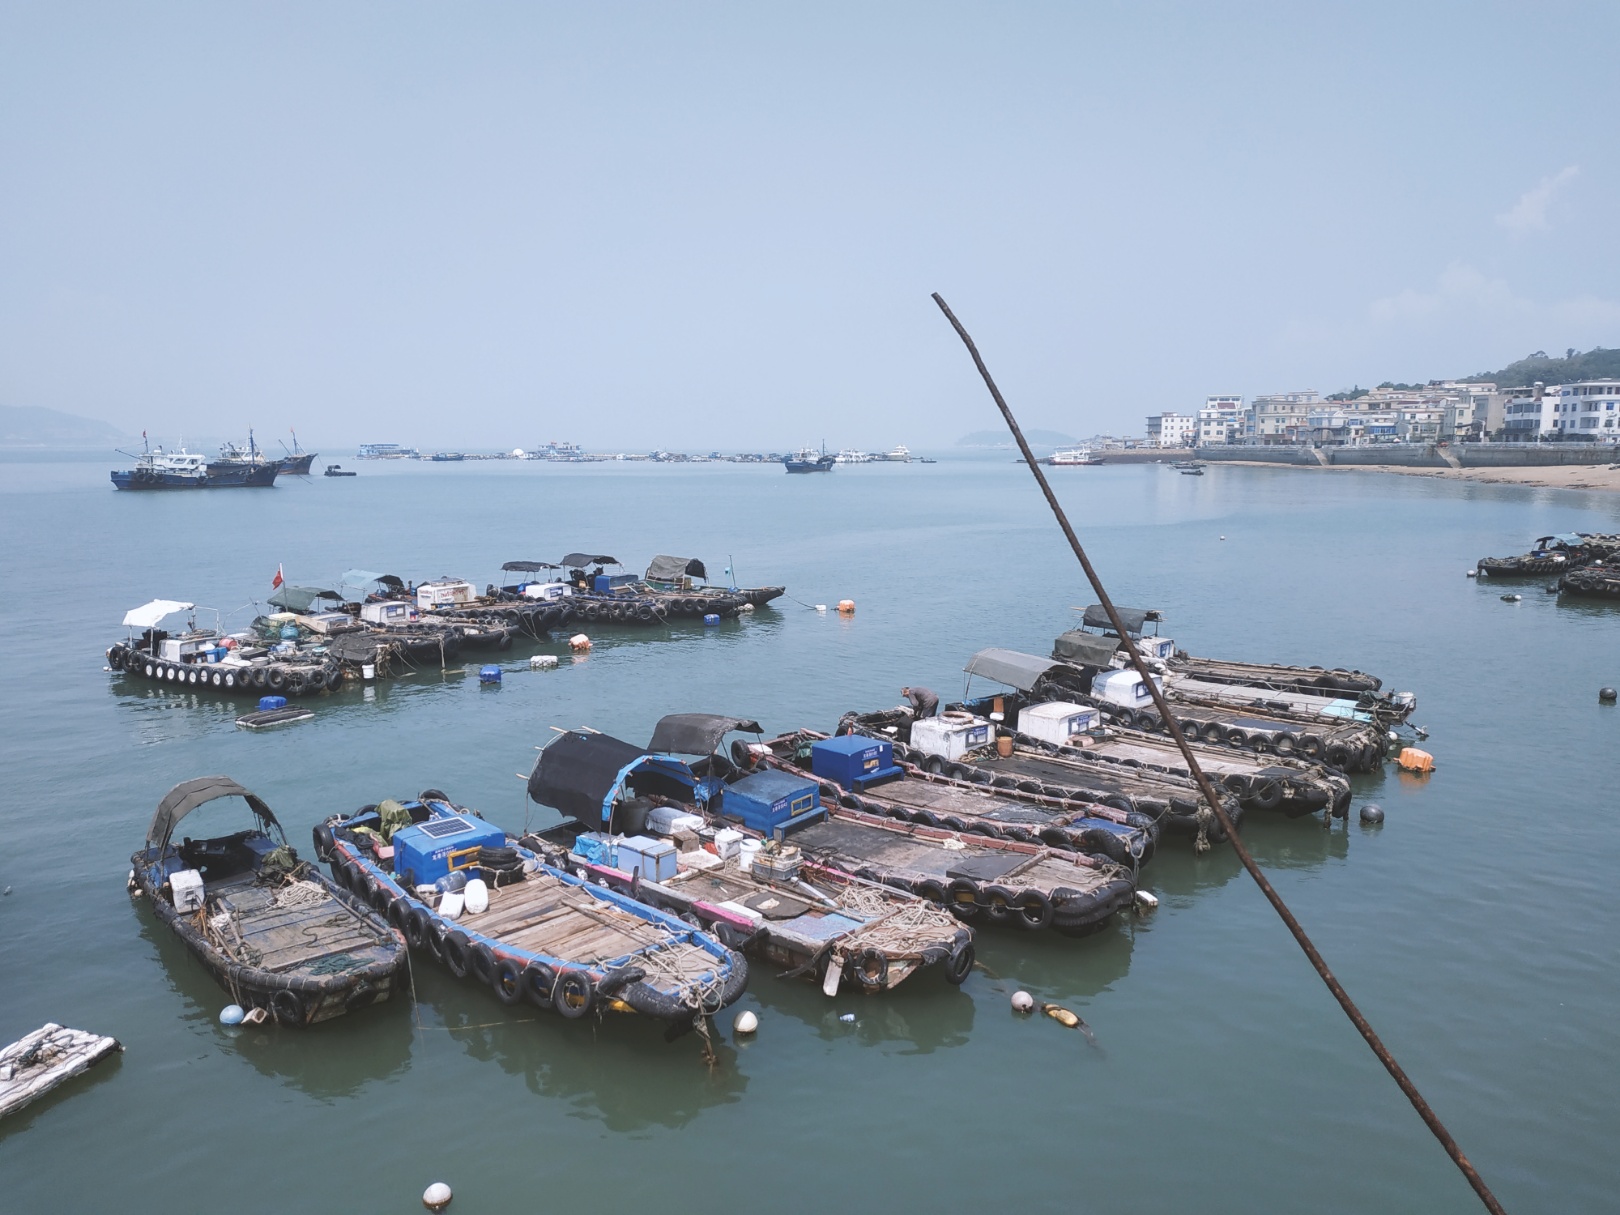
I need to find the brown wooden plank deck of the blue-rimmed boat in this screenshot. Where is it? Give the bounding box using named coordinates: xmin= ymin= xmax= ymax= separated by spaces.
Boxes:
xmin=462 ymin=873 xmax=719 ymax=980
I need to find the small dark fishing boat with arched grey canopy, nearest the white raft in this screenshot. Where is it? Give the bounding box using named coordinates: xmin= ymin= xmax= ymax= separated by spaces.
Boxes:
xmin=130 ymin=776 xmax=408 ymax=1025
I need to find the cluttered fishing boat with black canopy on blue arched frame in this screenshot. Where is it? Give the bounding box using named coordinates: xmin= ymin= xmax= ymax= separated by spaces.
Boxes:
xmin=528 ymin=714 xmax=974 ymax=995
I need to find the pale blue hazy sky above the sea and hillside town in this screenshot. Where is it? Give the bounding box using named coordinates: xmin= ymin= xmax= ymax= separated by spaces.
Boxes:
xmin=0 ymin=0 xmax=1620 ymax=449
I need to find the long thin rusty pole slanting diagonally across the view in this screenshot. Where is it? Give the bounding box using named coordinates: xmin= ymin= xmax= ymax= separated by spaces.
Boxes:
xmin=933 ymin=292 xmax=1507 ymax=1215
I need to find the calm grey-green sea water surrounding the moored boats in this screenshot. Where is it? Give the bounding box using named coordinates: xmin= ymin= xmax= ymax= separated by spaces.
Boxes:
xmin=0 ymin=454 xmax=1620 ymax=1215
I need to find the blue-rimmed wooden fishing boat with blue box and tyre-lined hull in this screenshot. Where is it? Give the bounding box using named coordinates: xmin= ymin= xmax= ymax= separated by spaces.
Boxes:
xmin=314 ymin=789 xmax=748 ymax=1035
